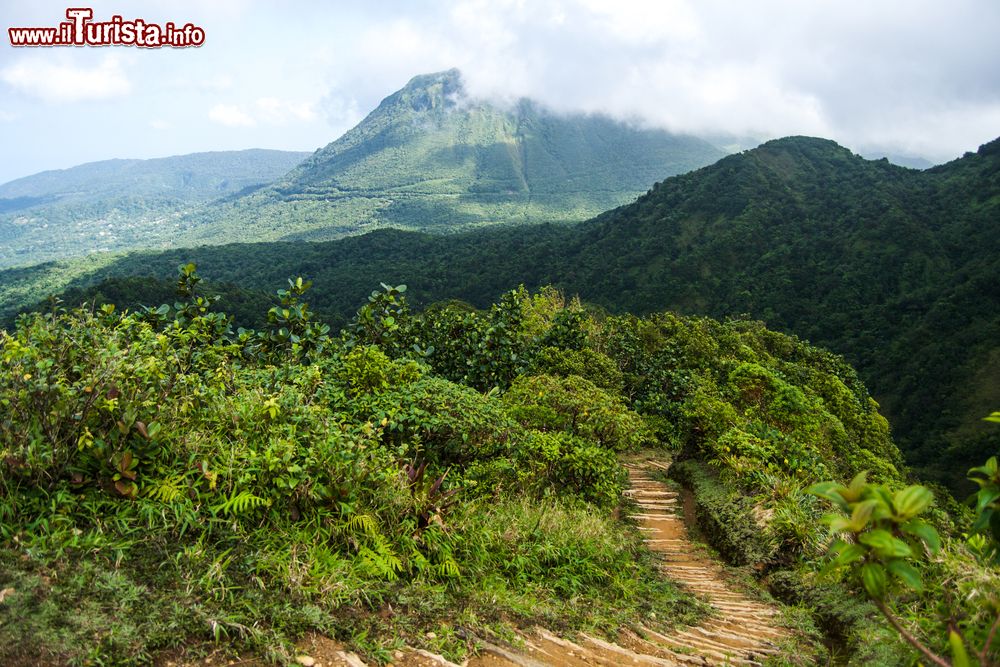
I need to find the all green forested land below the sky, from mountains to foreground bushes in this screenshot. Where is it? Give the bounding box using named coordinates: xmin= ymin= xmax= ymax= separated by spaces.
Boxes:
xmin=0 ymin=71 xmax=1000 ymax=667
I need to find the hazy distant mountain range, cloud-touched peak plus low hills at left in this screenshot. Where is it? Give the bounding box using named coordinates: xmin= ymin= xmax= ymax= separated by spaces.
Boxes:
xmin=0 ymin=70 xmax=725 ymax=266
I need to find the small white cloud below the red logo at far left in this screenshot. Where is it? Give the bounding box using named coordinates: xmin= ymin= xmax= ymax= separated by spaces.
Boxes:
xmin=0 ymin=53 xmax=132 ymax=102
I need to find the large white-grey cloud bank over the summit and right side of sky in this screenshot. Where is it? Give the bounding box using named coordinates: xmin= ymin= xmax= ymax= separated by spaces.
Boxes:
xmin=354 ymin=0 xmax=1000 ymax=157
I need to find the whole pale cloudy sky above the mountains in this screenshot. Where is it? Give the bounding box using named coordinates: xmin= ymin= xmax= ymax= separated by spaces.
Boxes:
xmin=0 ymin=0 xmax=1000 ymax=182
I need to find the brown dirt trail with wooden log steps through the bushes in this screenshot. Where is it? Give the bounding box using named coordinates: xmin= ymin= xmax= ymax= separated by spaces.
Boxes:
xmin=164 ymin=461 xmax=790 ymax=667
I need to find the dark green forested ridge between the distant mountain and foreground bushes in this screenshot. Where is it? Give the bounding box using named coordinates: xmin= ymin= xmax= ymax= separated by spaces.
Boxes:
xmin=0 ymin=137 xmax=1000 ymax=494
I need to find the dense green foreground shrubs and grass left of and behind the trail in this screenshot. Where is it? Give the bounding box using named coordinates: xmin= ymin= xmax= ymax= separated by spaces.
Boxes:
xmin=0 ymin=265 xmax=960 ymax=663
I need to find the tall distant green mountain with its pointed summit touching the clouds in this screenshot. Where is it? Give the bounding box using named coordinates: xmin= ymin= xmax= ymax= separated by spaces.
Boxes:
xmin=176 ymin=70 xmax=724 ymax=243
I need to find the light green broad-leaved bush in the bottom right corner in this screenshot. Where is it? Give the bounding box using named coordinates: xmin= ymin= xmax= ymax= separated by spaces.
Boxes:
xmin=808 ymin=468 xmax=1000 ymax=667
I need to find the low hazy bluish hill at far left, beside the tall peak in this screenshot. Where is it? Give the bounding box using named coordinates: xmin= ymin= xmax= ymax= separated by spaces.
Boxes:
xmin=0 ymin=149 xmax=309 ymax=266
